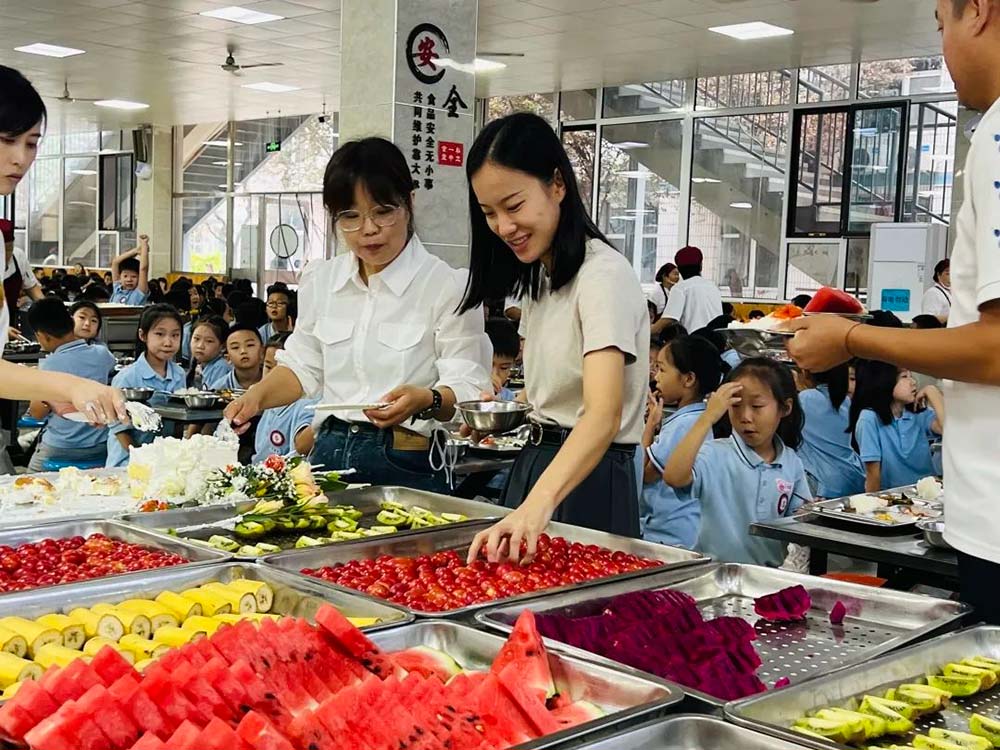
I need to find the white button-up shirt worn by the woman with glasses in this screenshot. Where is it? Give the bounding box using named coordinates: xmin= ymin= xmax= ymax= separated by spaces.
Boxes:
xmin=277 ymin=236 xmax=493 ymax=435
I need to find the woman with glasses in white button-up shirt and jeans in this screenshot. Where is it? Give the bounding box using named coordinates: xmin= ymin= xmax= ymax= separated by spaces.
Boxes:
xmin=226 ymin=138 xmax=492 ymax=491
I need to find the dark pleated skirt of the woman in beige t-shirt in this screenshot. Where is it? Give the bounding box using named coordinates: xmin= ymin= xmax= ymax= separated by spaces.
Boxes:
xmin=503 ymin=443 xmax=639 ymax=538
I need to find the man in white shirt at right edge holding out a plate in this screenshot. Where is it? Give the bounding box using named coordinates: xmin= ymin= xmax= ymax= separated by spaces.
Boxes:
xmin=788 ymin=0 xmax=1000 ymax=625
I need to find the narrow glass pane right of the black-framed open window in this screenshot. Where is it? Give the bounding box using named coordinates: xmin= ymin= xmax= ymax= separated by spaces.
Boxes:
xmin=903 ymin=101 xmax=958 ymax=224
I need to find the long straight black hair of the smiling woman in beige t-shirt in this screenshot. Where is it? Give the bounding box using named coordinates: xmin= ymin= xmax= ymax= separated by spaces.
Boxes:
xmin=460 ymin=112 xmax=610 ymax=312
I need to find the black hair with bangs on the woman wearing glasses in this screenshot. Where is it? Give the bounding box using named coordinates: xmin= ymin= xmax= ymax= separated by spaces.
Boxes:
xmin=323 ymin=138 xmax=414 ymax=234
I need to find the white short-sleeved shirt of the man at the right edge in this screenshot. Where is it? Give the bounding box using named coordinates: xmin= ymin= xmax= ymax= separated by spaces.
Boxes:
xmin=944 ymin=101 xmax=1000 ymax=563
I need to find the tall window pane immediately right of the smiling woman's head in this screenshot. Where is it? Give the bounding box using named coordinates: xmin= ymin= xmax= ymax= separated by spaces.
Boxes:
xmin=598 ymin=120 xmax=684 ymax=283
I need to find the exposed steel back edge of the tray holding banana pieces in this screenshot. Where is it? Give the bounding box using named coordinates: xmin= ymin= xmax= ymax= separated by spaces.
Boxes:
xmin=0 ymin=563 xmax=413 ymax=631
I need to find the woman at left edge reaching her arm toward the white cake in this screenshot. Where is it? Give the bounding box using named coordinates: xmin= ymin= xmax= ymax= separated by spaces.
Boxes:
xmin=0 ymin=65 xmax=127 ymax=424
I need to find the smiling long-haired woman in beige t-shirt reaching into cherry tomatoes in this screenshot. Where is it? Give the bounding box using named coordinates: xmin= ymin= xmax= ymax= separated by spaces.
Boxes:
xmin=462 ymin=113 xmax=649 ymax=560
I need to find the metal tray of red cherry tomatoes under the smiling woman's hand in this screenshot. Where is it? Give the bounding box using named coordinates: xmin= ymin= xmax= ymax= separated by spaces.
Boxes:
xmin=263 ymin=522 xmax=709 ymax=618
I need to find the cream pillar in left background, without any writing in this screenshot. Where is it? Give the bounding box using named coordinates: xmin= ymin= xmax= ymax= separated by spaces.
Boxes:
xmin=134 ymin=127 xmax=174 ymax=277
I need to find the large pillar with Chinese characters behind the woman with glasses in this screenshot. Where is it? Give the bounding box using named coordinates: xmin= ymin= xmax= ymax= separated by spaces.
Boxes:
xmin=340 ymin=0 xmax=478 ymax=267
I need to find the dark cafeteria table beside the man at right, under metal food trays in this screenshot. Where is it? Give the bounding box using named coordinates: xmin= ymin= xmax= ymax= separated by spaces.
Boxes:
xmin=750 ymin=514 xmax=958 ymax=583
